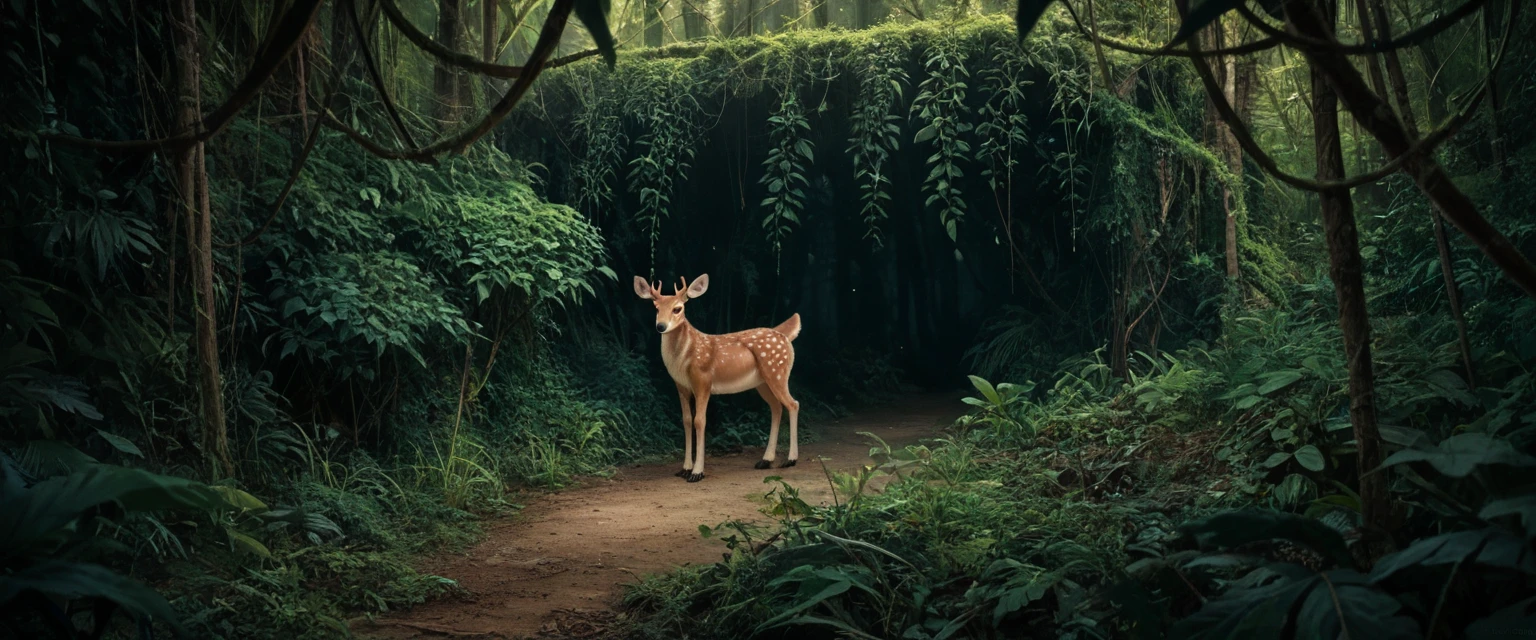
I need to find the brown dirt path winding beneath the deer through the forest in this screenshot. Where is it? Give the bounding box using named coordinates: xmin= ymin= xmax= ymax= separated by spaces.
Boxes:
xmin=353 ymin=394 xmax=963 ymax=638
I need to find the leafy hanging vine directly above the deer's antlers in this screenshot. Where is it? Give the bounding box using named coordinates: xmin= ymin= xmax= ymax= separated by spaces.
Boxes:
xmin=625 ymin=64 xmax=699 ymax=271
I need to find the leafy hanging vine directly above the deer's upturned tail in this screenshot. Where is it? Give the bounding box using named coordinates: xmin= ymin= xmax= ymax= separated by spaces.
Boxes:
xmin=759 ymin=84 xmax=814 ymax=261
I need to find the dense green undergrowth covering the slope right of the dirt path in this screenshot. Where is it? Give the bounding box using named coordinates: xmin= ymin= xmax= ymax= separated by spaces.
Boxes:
xmin=627 ymin=293 xmax=1536 ymax=638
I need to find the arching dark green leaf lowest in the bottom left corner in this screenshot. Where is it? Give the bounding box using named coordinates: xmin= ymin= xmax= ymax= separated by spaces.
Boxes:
xmin=0 ymin=560 xmax=184 ymax=634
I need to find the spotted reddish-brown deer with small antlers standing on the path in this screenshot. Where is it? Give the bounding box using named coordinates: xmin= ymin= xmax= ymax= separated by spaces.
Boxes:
xmin=634 ymin=273 xmax=800 ymax=482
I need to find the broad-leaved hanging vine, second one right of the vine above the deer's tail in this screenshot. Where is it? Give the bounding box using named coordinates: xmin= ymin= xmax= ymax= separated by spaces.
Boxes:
xmin=912 ymin=34 xmax=974 ymax=241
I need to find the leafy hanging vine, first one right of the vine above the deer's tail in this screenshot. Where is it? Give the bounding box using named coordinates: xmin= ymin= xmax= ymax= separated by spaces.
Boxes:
xmin=848 ymin=41 xmax=906 ymax=249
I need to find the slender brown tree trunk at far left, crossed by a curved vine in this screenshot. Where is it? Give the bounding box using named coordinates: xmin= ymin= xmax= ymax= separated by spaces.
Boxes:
xmin=170 ymin=0 xmax=235 ymax=477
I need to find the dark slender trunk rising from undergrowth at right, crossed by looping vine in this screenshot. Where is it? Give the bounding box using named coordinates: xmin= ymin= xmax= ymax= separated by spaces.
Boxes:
xmin=1312 ymin=2 xmax=1392 ymax=557
